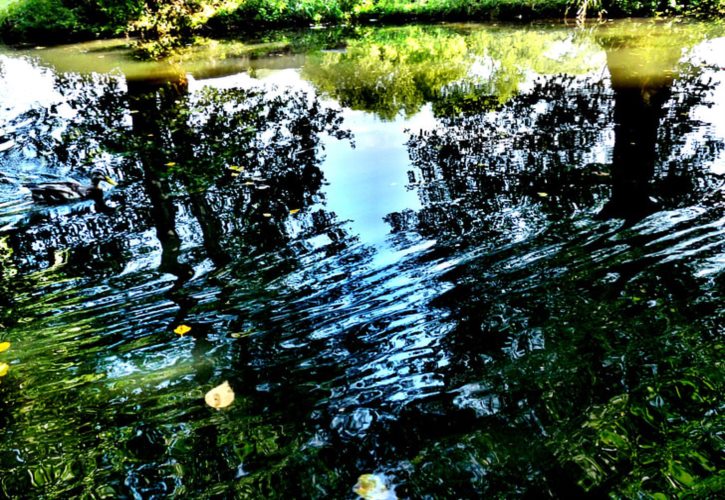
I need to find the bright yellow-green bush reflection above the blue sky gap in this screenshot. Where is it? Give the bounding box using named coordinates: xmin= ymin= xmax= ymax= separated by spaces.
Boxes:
xmin=303 ymin=27 xmax=597 ymax=119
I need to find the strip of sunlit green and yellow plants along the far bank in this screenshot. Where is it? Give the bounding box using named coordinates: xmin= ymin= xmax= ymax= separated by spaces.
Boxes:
xmin=0 ymin=0 xmax=724 ymax=57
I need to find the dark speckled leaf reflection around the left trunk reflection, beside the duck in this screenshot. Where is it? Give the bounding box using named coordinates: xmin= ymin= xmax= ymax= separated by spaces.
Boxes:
xmin=2 ymin=64 xmax=350 ymax=268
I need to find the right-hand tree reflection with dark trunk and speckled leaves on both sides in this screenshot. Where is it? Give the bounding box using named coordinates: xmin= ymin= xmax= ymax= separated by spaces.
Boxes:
xmin=402 ymin=46 xmax=721 ymax=246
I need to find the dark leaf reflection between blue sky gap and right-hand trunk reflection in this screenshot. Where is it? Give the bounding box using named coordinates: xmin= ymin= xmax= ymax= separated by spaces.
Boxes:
xmin=408 ymin=77 xmax=611 ymax=244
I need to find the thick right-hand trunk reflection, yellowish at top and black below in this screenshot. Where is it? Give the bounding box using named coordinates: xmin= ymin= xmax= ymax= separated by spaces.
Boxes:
xmin=598 ymin=25 xmax=717 ymax=220
